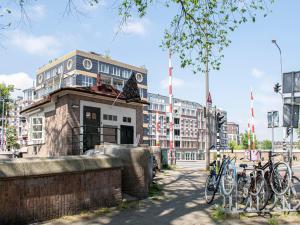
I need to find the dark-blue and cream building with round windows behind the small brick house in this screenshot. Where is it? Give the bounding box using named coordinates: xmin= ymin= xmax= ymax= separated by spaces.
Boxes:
xmin=34 ymin=50 xmax=148 ymax=143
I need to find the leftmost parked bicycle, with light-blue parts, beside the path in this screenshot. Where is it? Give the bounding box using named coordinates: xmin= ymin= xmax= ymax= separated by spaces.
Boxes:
xmin=205 ymin=156 xmax=236 ymax=204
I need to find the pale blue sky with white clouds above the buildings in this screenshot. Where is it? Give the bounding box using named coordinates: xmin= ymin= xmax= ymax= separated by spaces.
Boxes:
xmin=0 ymin=0 xmax=300 ymax=140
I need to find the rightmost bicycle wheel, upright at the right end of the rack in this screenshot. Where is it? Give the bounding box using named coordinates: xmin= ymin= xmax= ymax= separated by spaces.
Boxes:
xmin=270 ymin=162 xmax=292 ymax=195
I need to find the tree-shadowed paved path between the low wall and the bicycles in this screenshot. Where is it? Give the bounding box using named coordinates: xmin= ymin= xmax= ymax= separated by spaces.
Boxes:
xmin=40 ymin=168 xmax=299 ymax=225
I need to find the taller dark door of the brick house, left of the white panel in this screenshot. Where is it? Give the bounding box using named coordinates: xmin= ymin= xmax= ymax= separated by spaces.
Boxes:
xmin=83 ymin=106 xmax=100 ymax=151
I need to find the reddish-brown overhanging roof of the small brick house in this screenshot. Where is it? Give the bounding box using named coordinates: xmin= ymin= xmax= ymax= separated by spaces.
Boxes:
xmin=21 ymin=84 xmax=149 ymax=113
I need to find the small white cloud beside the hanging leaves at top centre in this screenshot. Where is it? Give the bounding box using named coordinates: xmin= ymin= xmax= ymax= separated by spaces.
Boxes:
xmin=115 ymin=19 xmax=149 ymax=36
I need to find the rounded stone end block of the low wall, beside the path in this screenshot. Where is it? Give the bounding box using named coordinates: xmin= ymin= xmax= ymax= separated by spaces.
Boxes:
xmin=97 ymin=144 xmax=152 ymax=199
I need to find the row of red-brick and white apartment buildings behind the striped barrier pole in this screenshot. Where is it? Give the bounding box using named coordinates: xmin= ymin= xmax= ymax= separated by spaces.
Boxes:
xmin=148 ymin=93 xmax=227 ymax=160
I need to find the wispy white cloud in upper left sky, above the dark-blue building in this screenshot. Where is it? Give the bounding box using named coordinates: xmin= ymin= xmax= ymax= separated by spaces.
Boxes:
xmin=9 ymin=31 xmax=61 ymax=56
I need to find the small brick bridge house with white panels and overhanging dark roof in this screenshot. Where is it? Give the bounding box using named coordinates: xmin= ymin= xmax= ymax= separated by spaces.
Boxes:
xmin=21 ymin=81 xmax=147 ymax=156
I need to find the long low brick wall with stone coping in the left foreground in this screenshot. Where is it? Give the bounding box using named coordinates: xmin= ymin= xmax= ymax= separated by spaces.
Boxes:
xmin=0 ymin=155 xmax=122 ymax=225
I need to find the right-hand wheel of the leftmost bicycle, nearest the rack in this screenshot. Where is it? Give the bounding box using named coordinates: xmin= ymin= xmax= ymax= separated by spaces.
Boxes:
xmin=221 ymin=161 xmax=236 ymax=195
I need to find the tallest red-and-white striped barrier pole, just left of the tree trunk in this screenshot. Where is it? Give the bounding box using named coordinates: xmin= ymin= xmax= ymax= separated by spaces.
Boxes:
xmin=168 ymin=50 xmax=175 ymax=164
